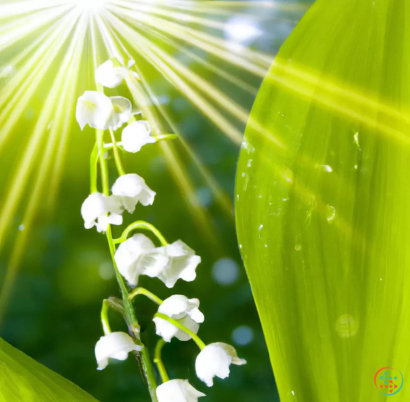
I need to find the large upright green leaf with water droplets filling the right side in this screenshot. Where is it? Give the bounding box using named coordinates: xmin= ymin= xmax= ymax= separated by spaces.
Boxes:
xmin=236 ymin=0 xmax=410 ymax=402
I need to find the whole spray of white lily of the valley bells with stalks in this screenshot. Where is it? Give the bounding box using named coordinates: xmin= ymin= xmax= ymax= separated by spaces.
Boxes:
xmin=76 ymin=59 xmax=246 ymax=402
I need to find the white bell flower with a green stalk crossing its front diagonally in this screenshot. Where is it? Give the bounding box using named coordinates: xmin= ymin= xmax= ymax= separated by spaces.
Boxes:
xmin=154 ymin=295 xmax=205 ymax=342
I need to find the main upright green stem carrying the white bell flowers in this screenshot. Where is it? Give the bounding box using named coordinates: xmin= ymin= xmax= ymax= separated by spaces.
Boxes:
xmin=97 ymin=130 xmax=158 ymax=402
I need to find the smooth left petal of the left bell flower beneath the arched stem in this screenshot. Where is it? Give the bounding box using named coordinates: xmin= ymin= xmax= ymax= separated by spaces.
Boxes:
xmin=114 ymin=233 xmax=155 ymax=286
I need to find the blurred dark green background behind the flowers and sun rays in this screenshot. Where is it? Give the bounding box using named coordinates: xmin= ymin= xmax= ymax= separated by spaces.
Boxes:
xmin=0 ymin=1 xmax=308 ymax=402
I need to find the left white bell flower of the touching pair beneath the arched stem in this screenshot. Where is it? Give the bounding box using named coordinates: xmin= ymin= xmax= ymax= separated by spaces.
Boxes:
xmin=114 ymin=233 xmax=168 ymax=286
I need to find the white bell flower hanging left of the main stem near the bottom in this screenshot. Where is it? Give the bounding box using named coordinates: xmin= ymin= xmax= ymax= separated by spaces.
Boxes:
xmin=95 ymin=332 xmax=143 ymax=370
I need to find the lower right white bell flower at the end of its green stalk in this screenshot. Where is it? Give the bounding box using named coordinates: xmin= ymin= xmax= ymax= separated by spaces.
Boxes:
xmin=195 ymin=342 xmax=246 ymax=387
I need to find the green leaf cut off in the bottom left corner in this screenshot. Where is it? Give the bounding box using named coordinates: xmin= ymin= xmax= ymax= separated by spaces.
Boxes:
xmin=0 ymin=338 xmax=97 ymax=402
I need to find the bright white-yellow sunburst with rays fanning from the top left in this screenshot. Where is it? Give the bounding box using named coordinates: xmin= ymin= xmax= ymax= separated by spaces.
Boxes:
xmin=0 ymin=0 xmax=306 ymax=313
